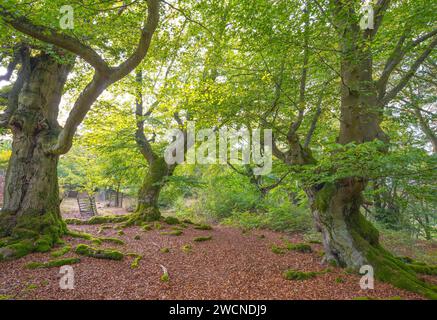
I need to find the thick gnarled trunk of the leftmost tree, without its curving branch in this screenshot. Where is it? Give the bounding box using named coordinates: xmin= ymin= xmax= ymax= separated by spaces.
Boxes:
xmin=0 ymin=54 xmax=70 ymax=260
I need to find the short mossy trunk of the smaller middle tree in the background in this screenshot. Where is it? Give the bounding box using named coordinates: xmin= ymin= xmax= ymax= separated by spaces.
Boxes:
xmin=134 ymin=158 xmax=169 ymax=221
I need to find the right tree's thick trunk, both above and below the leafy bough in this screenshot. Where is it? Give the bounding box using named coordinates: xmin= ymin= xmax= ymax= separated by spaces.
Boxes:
xmin=307 ymin=1 xmax=437 ymax=298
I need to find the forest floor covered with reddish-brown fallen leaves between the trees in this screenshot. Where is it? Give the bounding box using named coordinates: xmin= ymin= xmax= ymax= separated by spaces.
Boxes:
xmin=0 ymin=198 xmax=434 ymax=299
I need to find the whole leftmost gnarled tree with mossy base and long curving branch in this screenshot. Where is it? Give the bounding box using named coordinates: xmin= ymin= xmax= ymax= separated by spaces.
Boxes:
xmin=0 ymin=0 xmax=160 ymax=258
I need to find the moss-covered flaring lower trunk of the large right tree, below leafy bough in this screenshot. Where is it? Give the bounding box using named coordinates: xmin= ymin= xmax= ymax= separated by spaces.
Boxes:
xmin=308 ymin=178 xmax=437 ymax=299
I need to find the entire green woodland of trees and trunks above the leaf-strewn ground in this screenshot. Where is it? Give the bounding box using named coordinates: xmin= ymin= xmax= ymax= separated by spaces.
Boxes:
xmin=0 ymin=0 xmax=437 ymax=299
